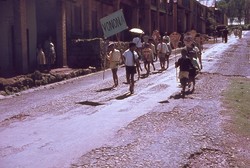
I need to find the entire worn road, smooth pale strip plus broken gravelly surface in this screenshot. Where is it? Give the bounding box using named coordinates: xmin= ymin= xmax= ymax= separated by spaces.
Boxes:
xmin=0 ymin=32 xmax=250 ymax=168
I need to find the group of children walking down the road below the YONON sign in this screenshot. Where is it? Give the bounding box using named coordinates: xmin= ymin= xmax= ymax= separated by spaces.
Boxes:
xmin=107 ymin=30 xmax=202 ymax=94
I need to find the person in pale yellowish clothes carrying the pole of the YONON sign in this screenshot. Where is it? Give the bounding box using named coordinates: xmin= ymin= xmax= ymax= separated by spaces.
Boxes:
xmin=107 ymin=43 xmax=121 ymax=87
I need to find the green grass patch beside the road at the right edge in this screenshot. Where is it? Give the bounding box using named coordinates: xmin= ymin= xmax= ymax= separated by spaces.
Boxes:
xmin=224 ymin=78 xmax=250 ymax=136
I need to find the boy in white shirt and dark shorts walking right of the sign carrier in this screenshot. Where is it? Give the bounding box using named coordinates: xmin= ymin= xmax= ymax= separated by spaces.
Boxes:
xmin=123 ymin=42 xmax=139 ymax=94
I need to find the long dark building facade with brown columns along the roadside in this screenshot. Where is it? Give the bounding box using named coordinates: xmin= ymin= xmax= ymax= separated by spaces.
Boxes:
xmin=0 ymin=0 xmax=225 ymax=77
